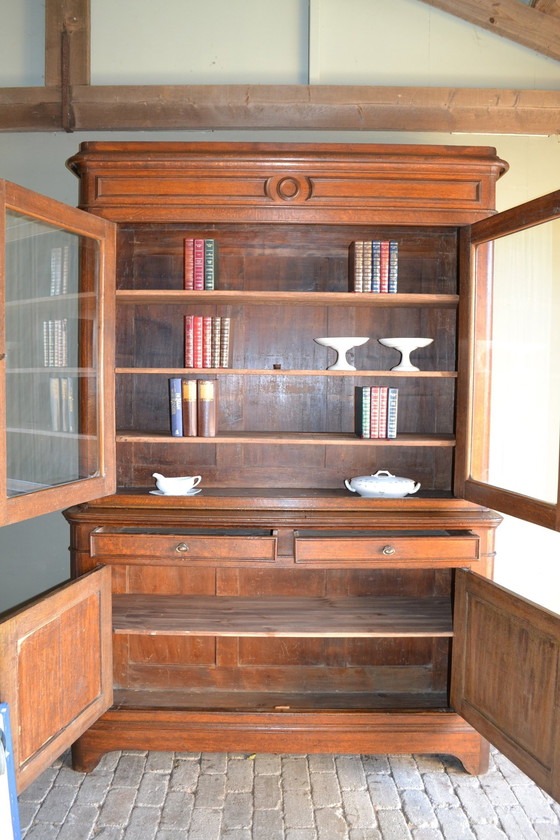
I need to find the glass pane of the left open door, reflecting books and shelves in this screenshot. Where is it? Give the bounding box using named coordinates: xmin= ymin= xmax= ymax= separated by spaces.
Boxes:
xmin=6 ymin=211 xmax=99 ymax=497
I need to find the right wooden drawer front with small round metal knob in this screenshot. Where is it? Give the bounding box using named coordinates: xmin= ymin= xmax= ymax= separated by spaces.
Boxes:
xmin=295 ymin=535 xmax=479 ymax=566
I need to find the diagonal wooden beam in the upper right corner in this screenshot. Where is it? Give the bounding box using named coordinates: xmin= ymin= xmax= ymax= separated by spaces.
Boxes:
xmin=421 ymin=0 xmax=560 ymax=61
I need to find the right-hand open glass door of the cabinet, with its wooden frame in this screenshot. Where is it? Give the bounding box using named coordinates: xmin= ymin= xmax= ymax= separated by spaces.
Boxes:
xmin=455 ymin=191 xmax=560 ymax=530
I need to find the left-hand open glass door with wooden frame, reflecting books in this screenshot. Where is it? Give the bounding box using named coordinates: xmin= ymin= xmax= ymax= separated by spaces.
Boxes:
xmin=0 ymin=182 xmax=114 ymax=524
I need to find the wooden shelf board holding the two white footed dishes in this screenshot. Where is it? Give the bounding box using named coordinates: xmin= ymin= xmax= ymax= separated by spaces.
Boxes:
xmin=115 ymin=367 xmax=457 ymax=379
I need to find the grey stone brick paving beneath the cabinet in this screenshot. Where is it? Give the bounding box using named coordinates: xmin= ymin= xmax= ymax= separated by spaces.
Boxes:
xmin=17 ymin=751 xmax=560 ymax=840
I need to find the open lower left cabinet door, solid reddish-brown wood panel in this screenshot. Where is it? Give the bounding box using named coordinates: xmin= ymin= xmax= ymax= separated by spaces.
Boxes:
xmin=0 ymin=566 xmax=113 ymax=793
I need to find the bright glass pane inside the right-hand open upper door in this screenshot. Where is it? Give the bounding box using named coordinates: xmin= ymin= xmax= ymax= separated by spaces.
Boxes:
xmin=472 ymin=221 xmax=560 ymax=503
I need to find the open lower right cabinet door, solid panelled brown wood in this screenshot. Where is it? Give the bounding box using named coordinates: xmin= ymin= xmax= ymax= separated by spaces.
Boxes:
xmin=451 ymin=570 xmax=560 ymax=801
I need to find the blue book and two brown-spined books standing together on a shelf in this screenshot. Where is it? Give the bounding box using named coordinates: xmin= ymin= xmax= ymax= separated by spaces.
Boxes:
xmin=169 ymin=377 xmax=218 ymax=437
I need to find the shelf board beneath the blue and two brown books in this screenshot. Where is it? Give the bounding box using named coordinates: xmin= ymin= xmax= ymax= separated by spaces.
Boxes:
xmin=117 ymin=430 xmax=455 ymax=447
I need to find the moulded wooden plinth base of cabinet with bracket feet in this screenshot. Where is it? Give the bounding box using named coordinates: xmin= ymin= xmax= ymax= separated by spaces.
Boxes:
xmin=72 ymin=709 xmax=488 ymax=775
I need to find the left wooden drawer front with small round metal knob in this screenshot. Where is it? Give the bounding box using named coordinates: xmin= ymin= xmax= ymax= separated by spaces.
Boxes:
xmin=90 ymin=533 xmax=276 ymax=564
